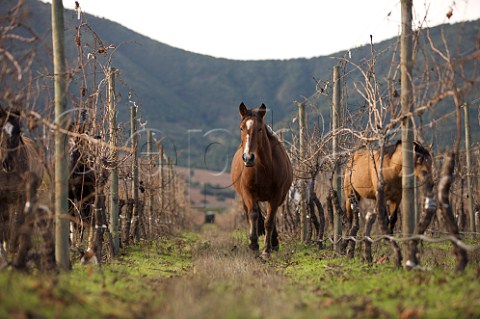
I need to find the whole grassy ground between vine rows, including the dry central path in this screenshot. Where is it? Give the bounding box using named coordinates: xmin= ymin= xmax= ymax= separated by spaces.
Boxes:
xmin=0 ymin=225 xmax=480 ymax=319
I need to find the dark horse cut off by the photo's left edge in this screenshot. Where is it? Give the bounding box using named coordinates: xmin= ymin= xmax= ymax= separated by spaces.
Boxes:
xmin=0 ymin=106 xmax=44 ymax=257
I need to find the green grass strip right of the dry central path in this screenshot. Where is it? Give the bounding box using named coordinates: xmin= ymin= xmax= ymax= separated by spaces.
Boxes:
xmin=279 ymin=245 xmax=480 ymax=318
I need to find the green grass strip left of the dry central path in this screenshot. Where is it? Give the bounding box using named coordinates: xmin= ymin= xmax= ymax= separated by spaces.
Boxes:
xmin=0 ymin=234 xmax=195 ymax=318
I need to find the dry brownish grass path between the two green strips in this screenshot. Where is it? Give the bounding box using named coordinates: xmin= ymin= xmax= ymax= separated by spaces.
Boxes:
xmin=145 ymin=230 xmax=312 ymax=319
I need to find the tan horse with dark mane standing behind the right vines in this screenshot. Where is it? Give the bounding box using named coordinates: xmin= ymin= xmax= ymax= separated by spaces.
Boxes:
xmin=343 ymin=140 xmax=432 ymax=233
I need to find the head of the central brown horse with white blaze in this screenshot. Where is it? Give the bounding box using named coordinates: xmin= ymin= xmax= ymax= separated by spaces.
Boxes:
xmin=239 ymin=102 xmax=267 ymax=167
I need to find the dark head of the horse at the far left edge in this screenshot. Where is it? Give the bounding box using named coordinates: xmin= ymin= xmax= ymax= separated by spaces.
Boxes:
xmin=0 ymin=106 xmax=21 ymax=172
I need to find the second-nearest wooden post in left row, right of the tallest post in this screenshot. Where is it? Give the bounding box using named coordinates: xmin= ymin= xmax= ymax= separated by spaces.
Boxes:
xmin=108 ymin=68 xmax=120 ymax=257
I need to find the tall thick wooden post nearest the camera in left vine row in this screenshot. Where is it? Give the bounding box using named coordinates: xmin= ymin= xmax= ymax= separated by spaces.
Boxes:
xmin=52 ymin=0 xmax=70 ymax=270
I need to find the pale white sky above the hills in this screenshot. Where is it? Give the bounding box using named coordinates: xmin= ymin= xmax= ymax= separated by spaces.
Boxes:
xmin=39 ymin=0 xmax=480 ymax=60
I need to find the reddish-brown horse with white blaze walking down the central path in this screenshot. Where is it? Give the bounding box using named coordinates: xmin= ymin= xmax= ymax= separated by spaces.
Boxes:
xmin=232 ymin=103 xmax=293 ymax=257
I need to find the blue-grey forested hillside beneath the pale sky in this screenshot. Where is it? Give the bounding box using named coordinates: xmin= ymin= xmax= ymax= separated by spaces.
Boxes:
xmin=2 ymin=0 xmax=480 ymax=168
